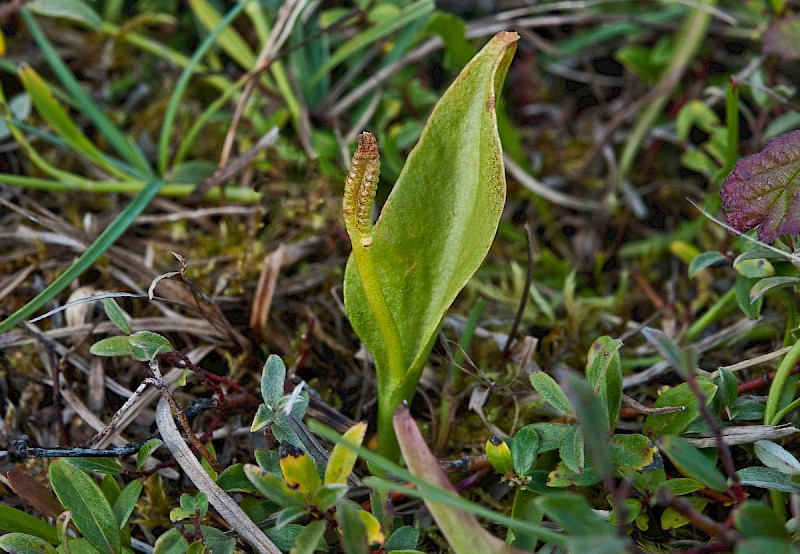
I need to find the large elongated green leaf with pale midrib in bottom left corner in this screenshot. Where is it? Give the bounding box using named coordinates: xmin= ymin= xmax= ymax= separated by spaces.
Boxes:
xmin=49 ymin=459 xmax=122 ymax=554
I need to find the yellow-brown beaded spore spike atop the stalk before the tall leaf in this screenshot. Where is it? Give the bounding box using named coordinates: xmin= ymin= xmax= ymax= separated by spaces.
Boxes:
xmin=342 ymin=131 xmax=381 ymax=248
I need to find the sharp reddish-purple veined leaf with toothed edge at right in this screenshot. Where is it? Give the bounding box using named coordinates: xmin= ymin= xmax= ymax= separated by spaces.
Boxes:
xmin=720 ymin=131 xmax=800 ymax=243
